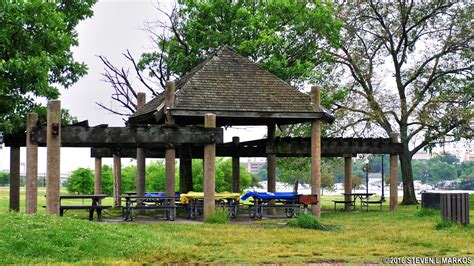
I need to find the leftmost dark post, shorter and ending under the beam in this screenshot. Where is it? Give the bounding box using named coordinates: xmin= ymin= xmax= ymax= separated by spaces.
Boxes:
xmin=10 ymin=147 xmax=20 ymax=212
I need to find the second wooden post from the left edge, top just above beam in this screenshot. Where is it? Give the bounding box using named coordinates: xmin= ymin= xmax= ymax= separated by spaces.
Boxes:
xmin=25 ymin=113 xmax=38 ymax=214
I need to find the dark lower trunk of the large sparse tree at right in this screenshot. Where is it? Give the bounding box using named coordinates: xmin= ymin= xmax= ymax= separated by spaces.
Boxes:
xmin=399 ymin=143 xmax=418 ymax=205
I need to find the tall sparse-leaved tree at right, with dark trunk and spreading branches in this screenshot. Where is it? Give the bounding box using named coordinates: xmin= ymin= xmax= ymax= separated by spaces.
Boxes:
xmin=328 ymin=1 xmax=474 ymax=204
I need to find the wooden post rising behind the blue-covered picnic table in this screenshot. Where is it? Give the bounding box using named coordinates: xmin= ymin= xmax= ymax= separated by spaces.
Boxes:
xmin=266 ymin=124 xmax=276 ymax=215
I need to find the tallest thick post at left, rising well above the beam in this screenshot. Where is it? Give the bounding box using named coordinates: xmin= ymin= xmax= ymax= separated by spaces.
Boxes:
xmin=46 ymin=100 xmax=61 ymax=215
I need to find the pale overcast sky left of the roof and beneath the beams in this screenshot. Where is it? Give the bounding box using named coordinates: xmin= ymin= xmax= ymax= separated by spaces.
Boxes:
xmin=0 ymin=0 xmax=266 ymax=174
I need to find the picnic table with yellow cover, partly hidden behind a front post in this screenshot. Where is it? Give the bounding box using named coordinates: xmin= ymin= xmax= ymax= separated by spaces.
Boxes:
xmin=180 ymin=191 xmax=240 ymax=219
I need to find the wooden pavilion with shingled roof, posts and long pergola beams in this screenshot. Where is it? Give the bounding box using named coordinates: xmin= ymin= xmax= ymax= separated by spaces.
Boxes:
xmin=6 ymin=46 xmax=401 ymax=216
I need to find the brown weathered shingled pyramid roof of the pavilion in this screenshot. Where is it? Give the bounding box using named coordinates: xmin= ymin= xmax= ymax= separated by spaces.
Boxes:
xmin=129 ymin=46 xmax=334 ymax=125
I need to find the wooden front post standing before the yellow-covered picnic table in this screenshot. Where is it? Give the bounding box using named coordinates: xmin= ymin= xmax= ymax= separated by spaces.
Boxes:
xmin=203 ymin=114 xmax=216 ymax=220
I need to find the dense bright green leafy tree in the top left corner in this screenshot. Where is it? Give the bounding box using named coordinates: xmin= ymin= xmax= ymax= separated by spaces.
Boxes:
xmin=0 ymin=0 xmax=95 ymax=134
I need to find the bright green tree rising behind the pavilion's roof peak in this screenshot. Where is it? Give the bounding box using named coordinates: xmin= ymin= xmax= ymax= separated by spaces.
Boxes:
xmin=98 ymin=0 xmax=341 ymax=115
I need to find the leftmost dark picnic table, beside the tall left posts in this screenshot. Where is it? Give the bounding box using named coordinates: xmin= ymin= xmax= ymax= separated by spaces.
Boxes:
xmin=59 ymin=194 xmax=112 ymax=221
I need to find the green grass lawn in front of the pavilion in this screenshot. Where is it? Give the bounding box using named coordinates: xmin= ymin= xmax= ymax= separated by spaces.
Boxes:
xmin=0 ymin=189 xmax=474 ymax=265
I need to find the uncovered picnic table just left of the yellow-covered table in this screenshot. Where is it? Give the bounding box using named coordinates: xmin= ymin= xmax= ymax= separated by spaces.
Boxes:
xmin=122 ymin=192 xmax=179 ymax=221
